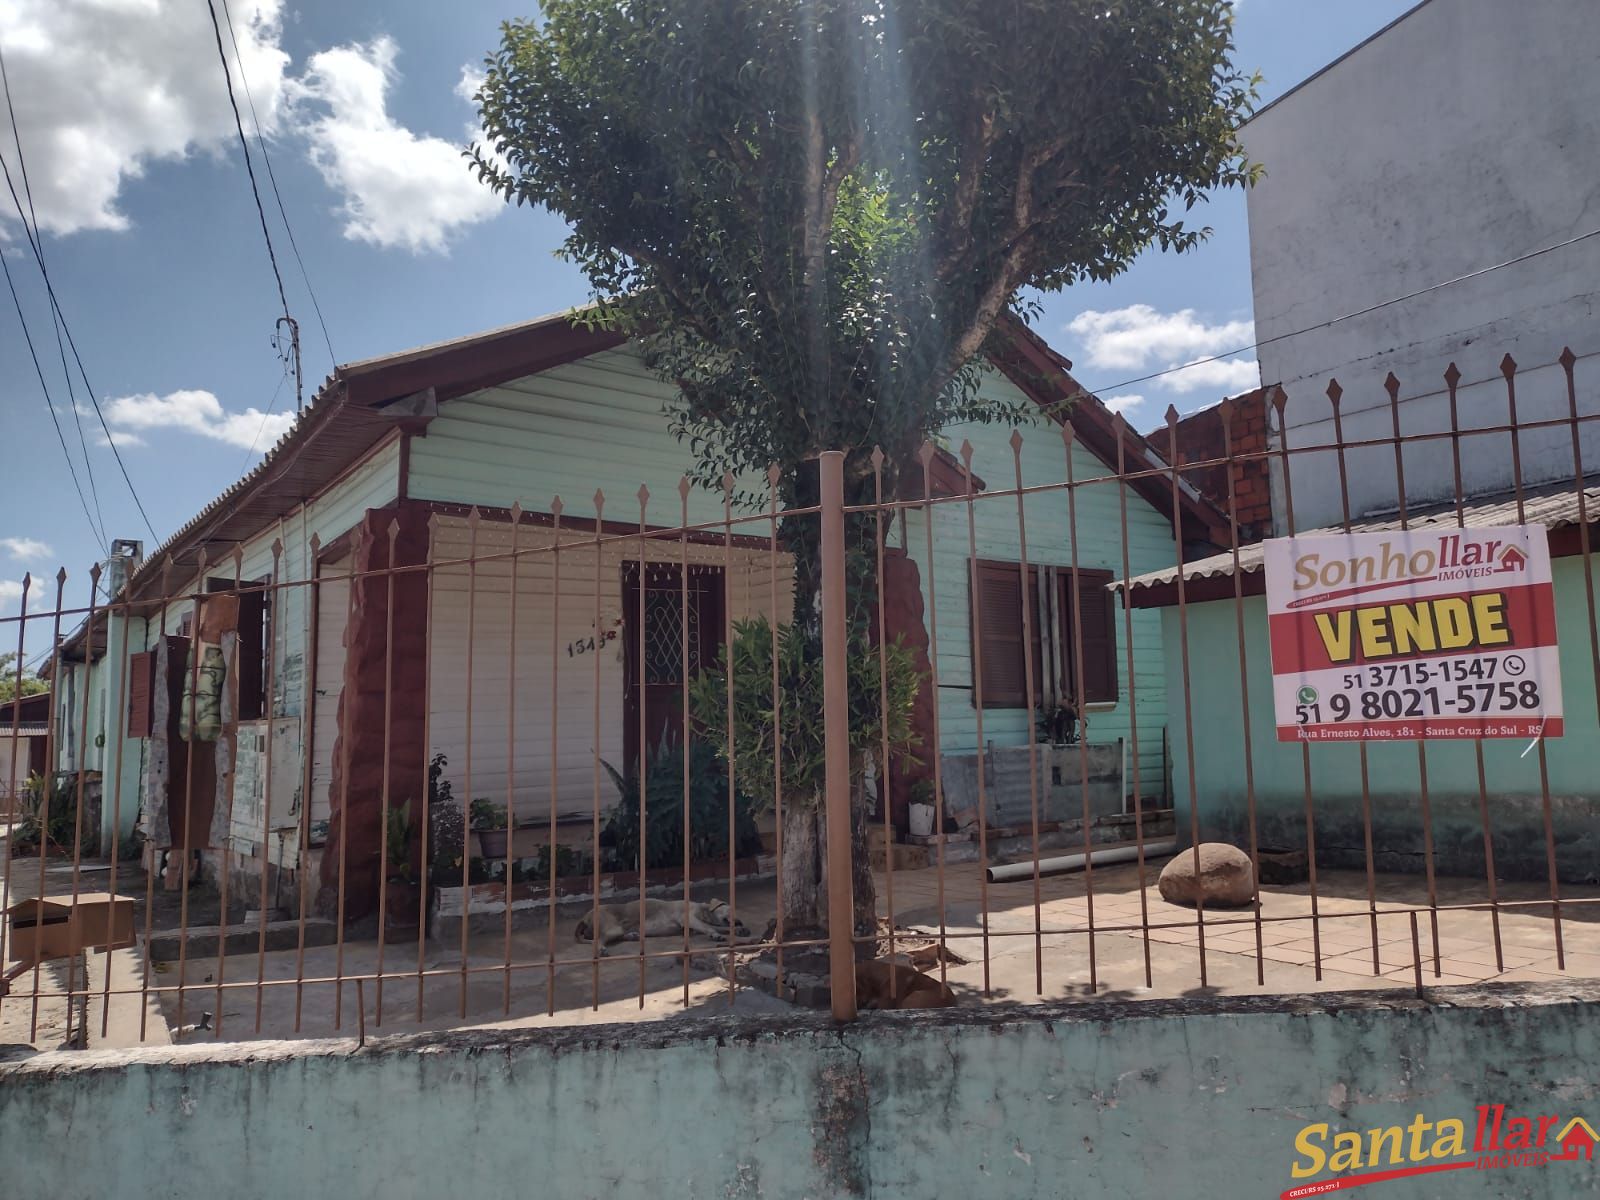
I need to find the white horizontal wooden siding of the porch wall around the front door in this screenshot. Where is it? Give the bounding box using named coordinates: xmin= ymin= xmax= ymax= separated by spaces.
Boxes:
xmin=429 ymin=517 xmax=792 ymax=821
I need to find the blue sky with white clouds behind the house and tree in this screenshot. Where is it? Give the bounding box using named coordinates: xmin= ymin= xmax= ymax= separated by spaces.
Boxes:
xmin=0 ymin=0 xmax=1411 ymax=614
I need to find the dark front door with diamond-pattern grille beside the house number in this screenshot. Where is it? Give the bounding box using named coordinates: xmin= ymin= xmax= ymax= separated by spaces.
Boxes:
xmin=622 ymin=562 xmax=723 ymax=766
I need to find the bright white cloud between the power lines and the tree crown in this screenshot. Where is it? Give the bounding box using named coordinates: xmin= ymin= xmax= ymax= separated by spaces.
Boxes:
xmin=293 ymin=37 xmax=504 ymax=253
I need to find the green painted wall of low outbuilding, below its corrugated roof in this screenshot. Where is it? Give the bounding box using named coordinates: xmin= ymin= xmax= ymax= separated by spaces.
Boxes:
xmin=1162 ymin=558 xmax=1600 ymax=882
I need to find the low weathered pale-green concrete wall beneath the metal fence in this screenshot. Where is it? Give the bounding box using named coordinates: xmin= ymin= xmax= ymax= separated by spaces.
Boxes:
xmin=0 ymin=982 xmax=1600 ymax=1200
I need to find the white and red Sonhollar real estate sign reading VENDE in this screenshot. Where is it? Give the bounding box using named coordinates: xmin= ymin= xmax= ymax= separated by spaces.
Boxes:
xmin=1264 ymin=525 xmax=1562 ymax=741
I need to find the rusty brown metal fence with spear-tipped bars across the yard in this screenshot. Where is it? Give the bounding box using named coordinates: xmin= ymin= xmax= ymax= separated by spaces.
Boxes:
xmin=0 ymin=352 xmax=1600 ymax=1042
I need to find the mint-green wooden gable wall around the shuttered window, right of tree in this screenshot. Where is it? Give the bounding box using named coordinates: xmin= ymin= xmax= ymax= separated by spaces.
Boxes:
xmin=906 ymin=371 xmax=1178 ymax=780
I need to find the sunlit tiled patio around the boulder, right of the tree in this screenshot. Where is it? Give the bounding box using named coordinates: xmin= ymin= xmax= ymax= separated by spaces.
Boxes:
xmin=878 ymin=859 xmax=1600 ymax=1000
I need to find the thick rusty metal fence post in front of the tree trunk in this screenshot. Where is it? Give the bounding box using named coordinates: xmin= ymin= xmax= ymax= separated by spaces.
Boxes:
xmin=821 ymin=450 xmax=856 ymax=1021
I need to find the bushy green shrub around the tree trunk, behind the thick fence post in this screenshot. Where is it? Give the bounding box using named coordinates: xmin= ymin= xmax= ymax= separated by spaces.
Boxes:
xmin=690 ymin=618 xmax=922 ymax=808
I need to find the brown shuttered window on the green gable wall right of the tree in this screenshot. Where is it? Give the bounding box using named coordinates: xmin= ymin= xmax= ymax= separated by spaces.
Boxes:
xmin=968 ymin=560 xmax=1117 ymax=709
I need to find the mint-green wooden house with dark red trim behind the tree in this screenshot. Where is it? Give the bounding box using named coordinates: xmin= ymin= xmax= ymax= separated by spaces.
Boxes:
xmin=58 ymin=315 xmax=1224 ymax=917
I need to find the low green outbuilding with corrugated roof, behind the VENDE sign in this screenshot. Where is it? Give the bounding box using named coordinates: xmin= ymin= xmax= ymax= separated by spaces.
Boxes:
xmin=1126 ymin=483 xmax=1600 ymax=883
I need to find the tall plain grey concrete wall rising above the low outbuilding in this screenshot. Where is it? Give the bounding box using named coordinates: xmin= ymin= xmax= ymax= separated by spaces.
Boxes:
xmin=1243 ymin=0 xmax=1600 ymax=528
